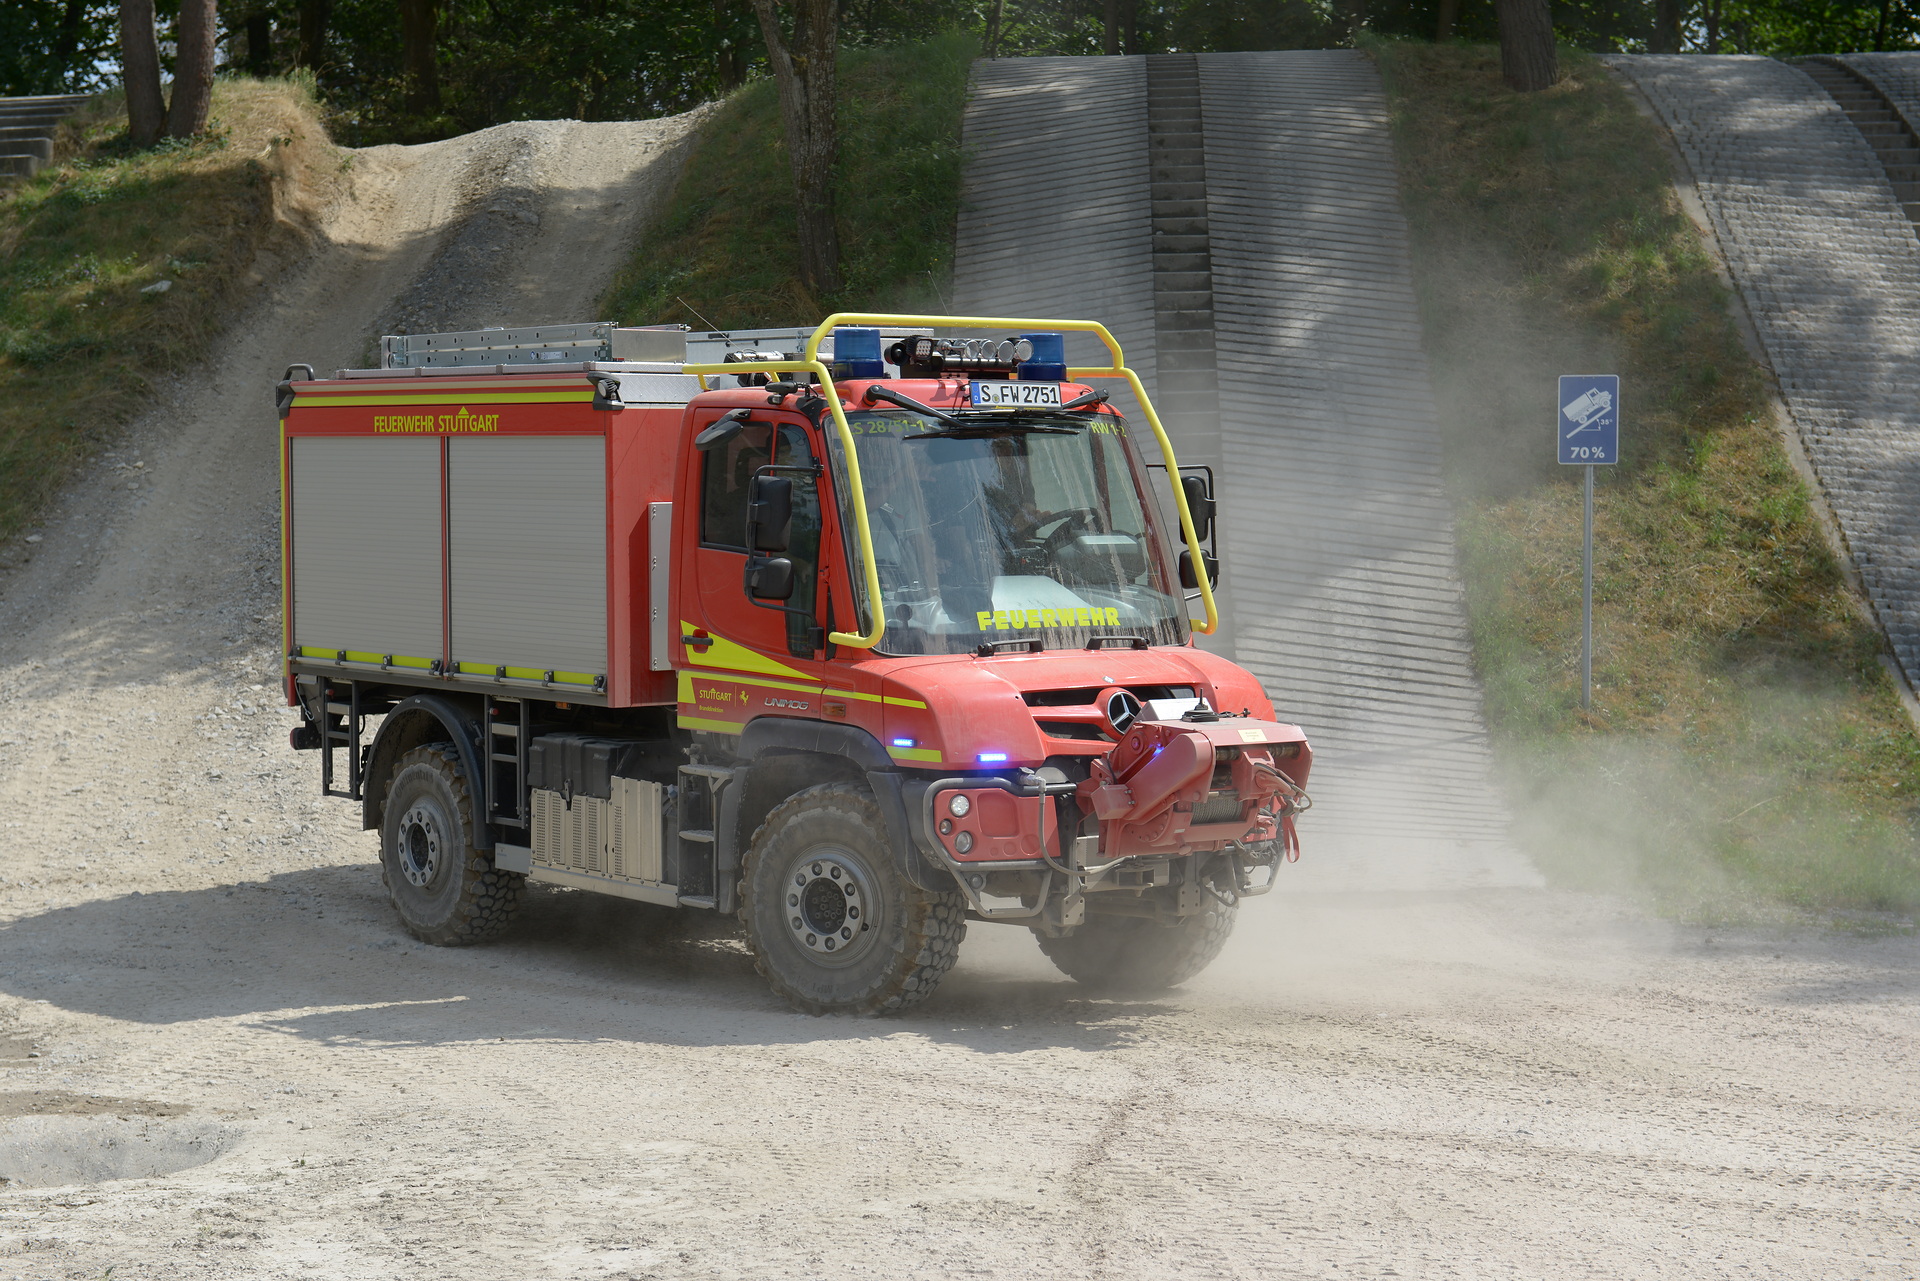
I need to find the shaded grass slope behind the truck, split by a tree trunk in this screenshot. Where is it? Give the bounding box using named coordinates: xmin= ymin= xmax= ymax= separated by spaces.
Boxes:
xmin=601 ymin=35 xmax=979 ymax=328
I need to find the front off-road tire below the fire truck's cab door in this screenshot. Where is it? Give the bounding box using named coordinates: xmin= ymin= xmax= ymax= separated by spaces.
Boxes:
xmin=739 ymin=784 xmax=966 ymax=1014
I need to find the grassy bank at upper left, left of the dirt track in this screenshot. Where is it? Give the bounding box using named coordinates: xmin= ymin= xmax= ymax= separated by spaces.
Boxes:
xmin=0 ymin=79 xmax=342 ymax=540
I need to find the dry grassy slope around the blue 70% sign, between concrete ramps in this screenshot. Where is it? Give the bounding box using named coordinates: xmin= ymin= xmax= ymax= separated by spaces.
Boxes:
xmin=1375 ymin=44 xmax=1920 ymax=918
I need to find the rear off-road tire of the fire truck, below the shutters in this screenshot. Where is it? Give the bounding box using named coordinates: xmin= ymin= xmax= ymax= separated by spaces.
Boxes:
xmin=380 ymin=743 xmax=526 ymax=947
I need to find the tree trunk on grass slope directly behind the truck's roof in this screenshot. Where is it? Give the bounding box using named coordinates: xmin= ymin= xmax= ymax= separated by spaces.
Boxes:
xmin=753 ymin=0 xmax=841 ymax=298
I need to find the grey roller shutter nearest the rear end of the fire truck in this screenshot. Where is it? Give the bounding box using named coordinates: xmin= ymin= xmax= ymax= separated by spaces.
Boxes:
xmin=290 ymin=436 xmax=442 ymax=666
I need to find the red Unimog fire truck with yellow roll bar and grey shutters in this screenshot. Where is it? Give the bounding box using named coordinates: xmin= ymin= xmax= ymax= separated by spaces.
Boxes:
xmin=276 ymin=315 xmax=1311 ymax=1012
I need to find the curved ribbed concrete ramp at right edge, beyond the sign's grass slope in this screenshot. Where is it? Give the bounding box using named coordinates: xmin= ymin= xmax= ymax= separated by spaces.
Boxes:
xmin=1609 ymin=56 xmax=1920 ymax=680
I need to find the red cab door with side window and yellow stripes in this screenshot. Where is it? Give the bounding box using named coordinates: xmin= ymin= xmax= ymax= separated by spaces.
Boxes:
xmin=678 ymin=411 xmax=824 ymax=734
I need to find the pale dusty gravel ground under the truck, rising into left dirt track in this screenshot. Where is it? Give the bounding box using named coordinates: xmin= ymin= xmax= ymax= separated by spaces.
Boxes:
xmin=0 ymin=105 xmax=1920 ymax=1281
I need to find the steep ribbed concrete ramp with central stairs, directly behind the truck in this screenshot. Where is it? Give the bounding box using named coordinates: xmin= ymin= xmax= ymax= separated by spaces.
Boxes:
xmin=956 ymin=52 xmax=1536 ymax=889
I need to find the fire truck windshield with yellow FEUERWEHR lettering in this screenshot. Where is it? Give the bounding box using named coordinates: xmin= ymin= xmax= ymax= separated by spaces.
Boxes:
xmin=835 ymin=409 xmax=1187 ymax=653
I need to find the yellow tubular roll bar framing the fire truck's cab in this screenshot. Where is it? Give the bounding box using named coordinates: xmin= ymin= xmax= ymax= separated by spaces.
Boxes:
xmin=684 ymin=311 xmax=1219 ymax=649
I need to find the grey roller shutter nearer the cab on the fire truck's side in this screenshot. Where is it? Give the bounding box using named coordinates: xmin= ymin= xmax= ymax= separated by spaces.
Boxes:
xmin=447 ymin=436 xmax=607 ymax=676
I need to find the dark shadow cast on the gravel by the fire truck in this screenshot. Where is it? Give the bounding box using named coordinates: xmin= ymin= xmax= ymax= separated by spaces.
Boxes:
xmin=0 ymin=864 xmax=1183 ymax=1052
